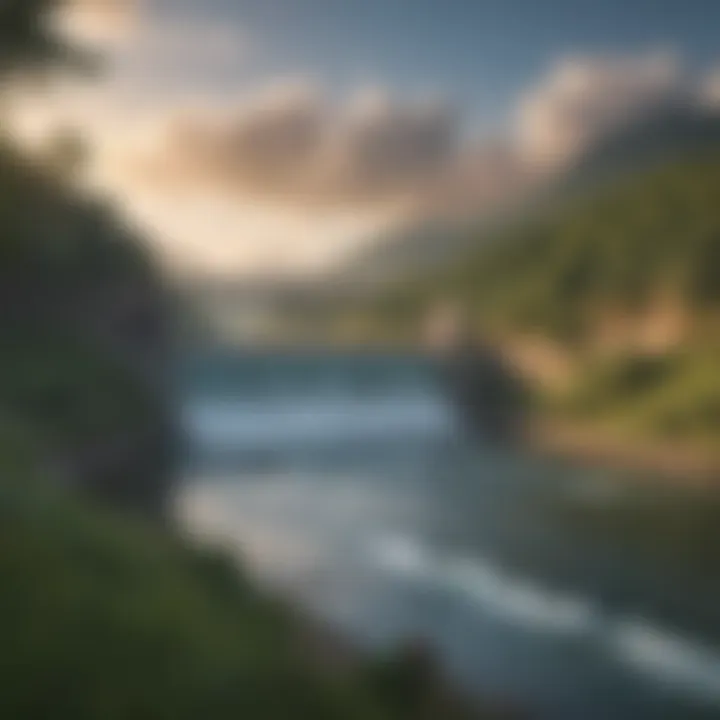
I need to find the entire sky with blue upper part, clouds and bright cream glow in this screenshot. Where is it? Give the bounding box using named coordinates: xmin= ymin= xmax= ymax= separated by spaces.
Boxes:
xmin=15 ymin=0 xmax=720 ymax=275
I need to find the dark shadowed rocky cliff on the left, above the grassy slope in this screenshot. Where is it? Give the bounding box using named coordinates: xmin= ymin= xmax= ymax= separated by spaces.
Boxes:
xmin=0 ymin=146 xmax=178 ymax=516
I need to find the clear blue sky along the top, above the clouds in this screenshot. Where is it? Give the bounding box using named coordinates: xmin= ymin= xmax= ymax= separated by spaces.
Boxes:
xmin=154 ymin=0 xmax=720 ymax=127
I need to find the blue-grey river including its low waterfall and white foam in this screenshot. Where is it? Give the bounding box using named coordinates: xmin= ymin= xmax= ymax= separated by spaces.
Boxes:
xmin=180 ymin=355 xmax=720 ymax=720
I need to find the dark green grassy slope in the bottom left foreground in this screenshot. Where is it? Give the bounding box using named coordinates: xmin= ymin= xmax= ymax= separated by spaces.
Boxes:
xmin=0 ymin=463 xmax=400 ymax=720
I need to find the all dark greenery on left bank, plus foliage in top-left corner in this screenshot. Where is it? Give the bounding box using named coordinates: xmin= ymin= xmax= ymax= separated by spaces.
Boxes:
xmin=0 ymin=0 xmax=492 ymax=720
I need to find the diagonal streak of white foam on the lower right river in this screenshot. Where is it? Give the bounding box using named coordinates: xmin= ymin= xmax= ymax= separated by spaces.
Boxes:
xmin=370 ymin=536 xmax=720 ymax=706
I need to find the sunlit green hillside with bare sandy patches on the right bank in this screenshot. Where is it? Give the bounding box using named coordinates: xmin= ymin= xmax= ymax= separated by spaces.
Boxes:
xmin=352 ymin=156 xmax=720 ymax=441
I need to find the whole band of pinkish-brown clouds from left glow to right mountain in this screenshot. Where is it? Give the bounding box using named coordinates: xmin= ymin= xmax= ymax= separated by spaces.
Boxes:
xmin=121 ymin=52 xmax=720 ymax=218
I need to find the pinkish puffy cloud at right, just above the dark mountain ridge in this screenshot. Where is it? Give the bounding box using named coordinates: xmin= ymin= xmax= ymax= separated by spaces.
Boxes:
xmin=517 ymin=52 xmax=694 ymax=166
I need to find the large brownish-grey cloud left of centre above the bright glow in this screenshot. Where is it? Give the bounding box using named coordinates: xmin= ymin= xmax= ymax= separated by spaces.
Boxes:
xmin=125 ymin=79 xmax=459 ymax=211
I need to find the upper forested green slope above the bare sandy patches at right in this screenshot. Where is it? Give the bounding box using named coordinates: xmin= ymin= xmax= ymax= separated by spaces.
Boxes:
xmin=374 ymin=155 xmax=720 ymax=342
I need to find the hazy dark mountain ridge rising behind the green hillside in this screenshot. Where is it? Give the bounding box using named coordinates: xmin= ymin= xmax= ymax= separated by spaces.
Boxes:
xmin=333 ymin=107 xmax=720 ymax=291
